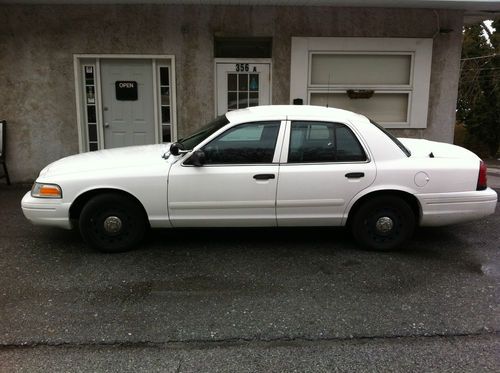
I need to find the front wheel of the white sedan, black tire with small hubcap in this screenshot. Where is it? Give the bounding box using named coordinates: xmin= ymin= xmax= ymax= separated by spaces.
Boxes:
xmin=78 ymin=193 xmax=147 ymax=253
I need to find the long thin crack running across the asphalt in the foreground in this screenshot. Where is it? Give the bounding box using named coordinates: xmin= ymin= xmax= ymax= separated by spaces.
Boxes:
xmin=0 ymin=330 xmax=500 ymax=351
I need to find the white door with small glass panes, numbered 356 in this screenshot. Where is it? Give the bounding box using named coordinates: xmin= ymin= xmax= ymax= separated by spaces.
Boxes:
xmin=216 ymin=60 xmax=271 ymax=115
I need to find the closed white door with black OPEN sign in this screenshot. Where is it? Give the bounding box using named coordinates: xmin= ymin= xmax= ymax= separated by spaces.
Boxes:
xmin=101 ymin=60 xmax=155 ymax=148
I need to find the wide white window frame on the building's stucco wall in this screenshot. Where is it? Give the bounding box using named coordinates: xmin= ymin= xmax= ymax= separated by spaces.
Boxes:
xmin=290 ymin=37 xmax=433 ymax=129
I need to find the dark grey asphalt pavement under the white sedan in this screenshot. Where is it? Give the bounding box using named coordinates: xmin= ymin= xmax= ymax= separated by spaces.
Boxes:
xmin=0 ymin=187 xmax=500 ymax=372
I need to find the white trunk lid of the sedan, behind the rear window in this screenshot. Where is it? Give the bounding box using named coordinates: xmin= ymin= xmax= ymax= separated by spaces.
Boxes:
xmin=398 ymin=138 xmax=479 ymax=159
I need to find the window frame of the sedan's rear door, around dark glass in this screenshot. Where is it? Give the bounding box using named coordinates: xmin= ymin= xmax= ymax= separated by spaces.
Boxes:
xmin=280 ymin=119 xmax=371 ymax=166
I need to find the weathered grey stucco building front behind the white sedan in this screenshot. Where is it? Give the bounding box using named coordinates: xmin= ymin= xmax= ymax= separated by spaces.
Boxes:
xmin=0 ymin=1 xmax=496 ymax=182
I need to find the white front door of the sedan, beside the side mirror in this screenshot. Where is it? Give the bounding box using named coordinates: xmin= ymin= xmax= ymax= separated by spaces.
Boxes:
xmin=168 ymin=121 xmax=285 ymax=227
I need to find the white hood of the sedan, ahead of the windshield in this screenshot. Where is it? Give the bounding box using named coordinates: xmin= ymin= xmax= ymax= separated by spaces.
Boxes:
xmin=40 ymin=144 xmax=170 ymax=176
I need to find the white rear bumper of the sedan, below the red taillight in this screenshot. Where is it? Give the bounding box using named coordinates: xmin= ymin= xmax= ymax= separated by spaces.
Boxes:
xmin=416 ymin=188 xmax=498 ymax=226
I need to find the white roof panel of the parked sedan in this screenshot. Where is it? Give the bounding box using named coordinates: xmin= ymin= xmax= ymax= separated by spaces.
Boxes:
xmin=226 ymin=105 xmax=368 ymax=123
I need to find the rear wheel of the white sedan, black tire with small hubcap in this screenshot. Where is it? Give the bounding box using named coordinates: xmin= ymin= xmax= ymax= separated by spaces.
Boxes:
xmin=351 ymin=196 xmax=416 ymax=251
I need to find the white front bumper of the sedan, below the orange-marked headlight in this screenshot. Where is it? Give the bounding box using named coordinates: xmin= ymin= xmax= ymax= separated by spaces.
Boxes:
xmin=21 ymin=192 xmax=73 ymax=229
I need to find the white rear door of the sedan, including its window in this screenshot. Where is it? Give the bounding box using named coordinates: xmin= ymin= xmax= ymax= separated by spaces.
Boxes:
xmin=276 ymin=120 xmax=376 ymax=226
